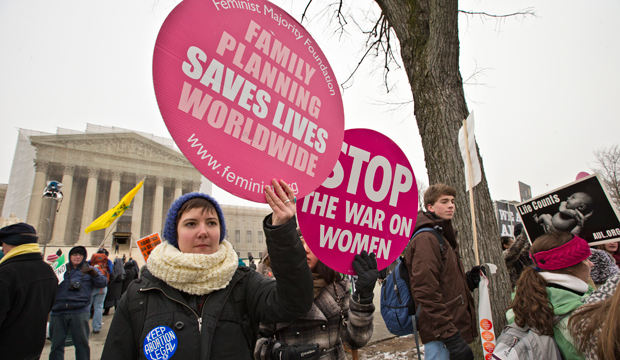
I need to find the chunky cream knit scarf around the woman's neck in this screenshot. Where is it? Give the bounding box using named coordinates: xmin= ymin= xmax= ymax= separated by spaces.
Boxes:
xmin=147 ymin=240 xmax=239 ymax=295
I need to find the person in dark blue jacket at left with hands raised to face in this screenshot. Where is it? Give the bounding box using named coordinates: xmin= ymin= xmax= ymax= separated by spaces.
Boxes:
xmin=50 ymin=246 xmax=108 ymax=360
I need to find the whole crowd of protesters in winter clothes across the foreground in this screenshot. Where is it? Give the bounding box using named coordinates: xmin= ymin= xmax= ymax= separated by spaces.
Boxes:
xmin=0 ymin=180 xmax=620 ymax=360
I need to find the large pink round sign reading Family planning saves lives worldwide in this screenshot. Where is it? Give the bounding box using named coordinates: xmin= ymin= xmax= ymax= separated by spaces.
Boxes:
xmin=153 ymin=0 xmax=344 ymax=202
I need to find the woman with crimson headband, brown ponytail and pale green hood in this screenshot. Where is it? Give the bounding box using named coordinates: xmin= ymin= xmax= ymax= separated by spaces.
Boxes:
xmin=506 ymin=231 xmax=594 ymax=359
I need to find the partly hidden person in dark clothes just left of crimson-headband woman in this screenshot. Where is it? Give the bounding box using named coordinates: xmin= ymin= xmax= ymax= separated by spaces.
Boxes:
xmin=502 ymin=223 xmax=533 ymax=289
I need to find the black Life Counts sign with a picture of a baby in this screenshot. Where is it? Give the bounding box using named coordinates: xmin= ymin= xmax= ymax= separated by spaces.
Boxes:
xmin=517 ymin=174 xmax=620 ymax=245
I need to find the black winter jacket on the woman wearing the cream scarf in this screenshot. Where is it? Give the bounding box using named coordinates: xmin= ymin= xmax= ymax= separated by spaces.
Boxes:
xmin=101 ymin=215 xmax=313 ymax=360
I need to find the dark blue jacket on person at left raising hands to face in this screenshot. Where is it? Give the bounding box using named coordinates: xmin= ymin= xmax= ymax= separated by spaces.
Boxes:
xmin=52 ymin=261 xmax=108 ymax=315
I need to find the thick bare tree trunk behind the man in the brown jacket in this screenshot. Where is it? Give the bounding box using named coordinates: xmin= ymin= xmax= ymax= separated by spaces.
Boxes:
xmin=376 ymin=0 xmax=511 ymax=335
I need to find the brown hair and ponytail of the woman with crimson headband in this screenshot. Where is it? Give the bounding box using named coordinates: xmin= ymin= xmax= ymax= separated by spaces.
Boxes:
xmin=510 ymin=231 xmax=588 ymax=336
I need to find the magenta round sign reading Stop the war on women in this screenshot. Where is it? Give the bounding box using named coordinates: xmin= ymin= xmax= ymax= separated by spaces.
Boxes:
xmin=297 ymin=129 xmax=418 ymax=275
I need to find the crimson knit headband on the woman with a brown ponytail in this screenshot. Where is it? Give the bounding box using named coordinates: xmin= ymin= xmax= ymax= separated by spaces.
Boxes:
xmin=530 ymin=235 xmax=591 ymax=270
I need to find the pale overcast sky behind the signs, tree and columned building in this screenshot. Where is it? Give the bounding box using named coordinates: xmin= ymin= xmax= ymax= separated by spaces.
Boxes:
xmin=0 ymin=0 xmax=620 ymax=206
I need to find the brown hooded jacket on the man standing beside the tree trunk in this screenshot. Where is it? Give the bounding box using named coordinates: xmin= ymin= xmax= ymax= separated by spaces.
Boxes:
xmin=405 ymin=212 xmax=478 ymax=344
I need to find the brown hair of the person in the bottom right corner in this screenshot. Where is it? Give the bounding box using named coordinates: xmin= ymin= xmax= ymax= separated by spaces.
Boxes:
xmin=568 ymin=282 xmax=620 ymax=359
